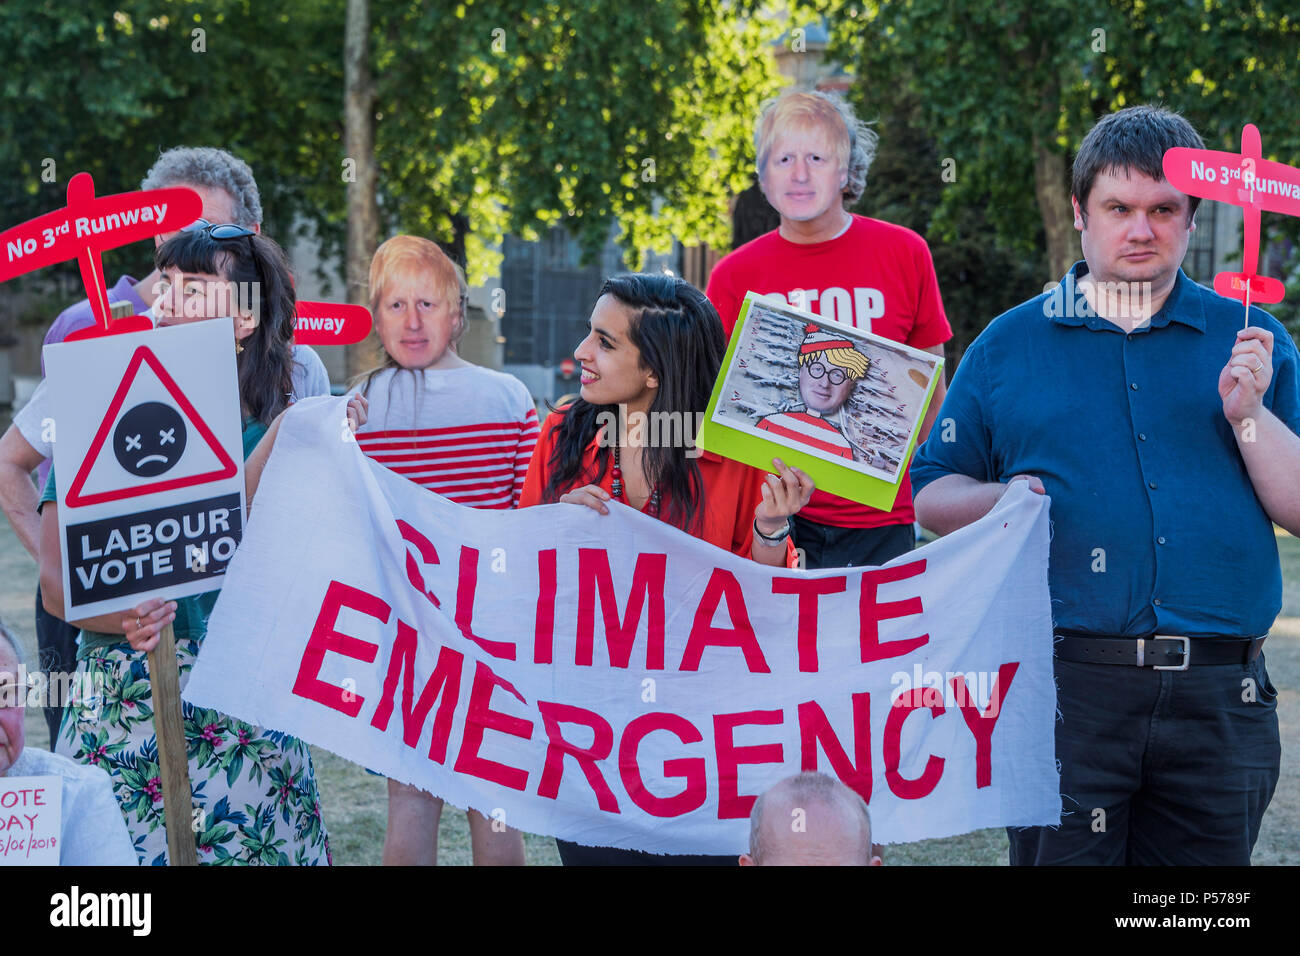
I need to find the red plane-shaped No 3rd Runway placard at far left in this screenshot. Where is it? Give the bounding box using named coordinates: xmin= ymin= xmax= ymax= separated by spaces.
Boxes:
xmin=0 ymin=173 xmax=203 ymax=338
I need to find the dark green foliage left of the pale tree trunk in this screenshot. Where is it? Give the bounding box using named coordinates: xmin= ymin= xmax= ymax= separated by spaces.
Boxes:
xmin=0 ymin=0 xmax=342 ymax=283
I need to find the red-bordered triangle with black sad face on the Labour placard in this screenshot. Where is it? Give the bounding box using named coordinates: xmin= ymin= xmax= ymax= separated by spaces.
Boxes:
xmin=66 ymin=345 xmax=238 ymax=507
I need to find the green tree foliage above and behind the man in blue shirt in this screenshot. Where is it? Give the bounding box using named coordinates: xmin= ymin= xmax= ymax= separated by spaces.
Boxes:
xmin=810 ymin=0 xmax=1300 ymax=303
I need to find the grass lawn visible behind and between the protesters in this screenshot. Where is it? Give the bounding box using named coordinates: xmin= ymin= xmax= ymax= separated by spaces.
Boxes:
xmin=0 ymin=509 xmax=1300 ymax=866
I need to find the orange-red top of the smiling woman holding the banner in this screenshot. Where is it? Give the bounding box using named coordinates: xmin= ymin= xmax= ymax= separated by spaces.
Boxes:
xmin=519 ymin=410 xmax=798 ymax=567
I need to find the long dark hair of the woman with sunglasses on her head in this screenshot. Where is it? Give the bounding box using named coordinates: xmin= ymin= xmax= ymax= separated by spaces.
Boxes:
xmin=153 ymin=229 xmax=298 ymax=425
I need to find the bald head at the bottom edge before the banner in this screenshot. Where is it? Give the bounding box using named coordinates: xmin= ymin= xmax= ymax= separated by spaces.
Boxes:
xmin=740 ymin=773 xmax=880 ymax=866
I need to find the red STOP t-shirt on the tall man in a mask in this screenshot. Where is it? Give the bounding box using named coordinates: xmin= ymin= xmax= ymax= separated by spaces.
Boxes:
xmin=705 ymin=216 xmax=953 ymax=528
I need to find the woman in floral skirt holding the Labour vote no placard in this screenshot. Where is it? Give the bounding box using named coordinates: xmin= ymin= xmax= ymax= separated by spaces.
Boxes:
xmin=40 ymin=225 xmax=338 ymax=865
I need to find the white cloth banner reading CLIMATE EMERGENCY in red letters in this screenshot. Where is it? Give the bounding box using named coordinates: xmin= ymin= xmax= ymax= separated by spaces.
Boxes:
xmin=185 ymin=399 xmax=1061 ymax=853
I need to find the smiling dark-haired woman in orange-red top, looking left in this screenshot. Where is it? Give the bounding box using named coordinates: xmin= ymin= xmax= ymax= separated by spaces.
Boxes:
xmin=520 ymin=274 xmax=814 ymax=866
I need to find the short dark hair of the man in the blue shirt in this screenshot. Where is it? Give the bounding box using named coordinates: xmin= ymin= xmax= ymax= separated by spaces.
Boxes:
xmin=1070 ymin=105 xmax=1205 ymax=222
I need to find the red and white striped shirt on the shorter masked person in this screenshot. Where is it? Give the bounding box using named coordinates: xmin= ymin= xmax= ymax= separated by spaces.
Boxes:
xmin=352 ymin=365 xmax=537 ymax=509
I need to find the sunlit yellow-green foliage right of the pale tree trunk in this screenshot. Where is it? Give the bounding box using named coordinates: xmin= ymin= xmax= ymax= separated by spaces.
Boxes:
xmin=372 ymin=0 xmax=776 ymax=280
